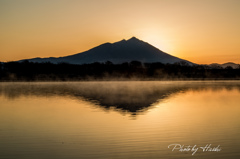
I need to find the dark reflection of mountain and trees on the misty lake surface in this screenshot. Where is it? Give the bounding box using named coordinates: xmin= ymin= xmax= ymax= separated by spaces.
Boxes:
xmin=0 ymin=81 xmax=240 ymax=114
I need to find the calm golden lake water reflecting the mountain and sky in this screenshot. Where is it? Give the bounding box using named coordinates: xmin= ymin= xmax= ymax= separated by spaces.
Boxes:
xmin=0 ymin=81 xmax=240 ymax=159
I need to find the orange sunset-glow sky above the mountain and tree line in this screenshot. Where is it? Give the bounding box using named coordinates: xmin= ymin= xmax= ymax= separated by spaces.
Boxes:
xmin=0 ymin=0 xmax=240 ymax=64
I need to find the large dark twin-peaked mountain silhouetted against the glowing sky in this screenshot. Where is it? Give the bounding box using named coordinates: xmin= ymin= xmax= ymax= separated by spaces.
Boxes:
xmin=21 ymin=37 xmax=193 ymax=65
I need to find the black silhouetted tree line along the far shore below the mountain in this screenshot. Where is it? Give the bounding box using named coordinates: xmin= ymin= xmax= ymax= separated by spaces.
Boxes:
xmin=0 ymin=61 xmax=240 ymax=81
